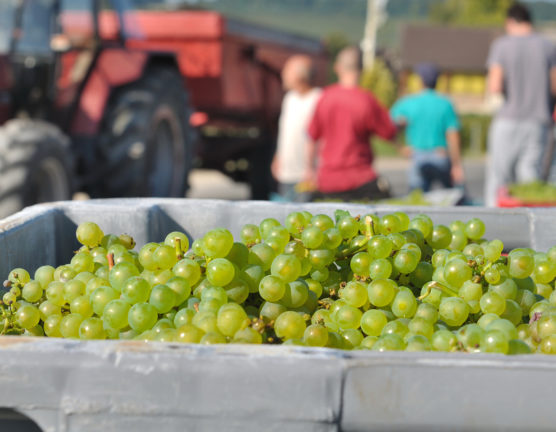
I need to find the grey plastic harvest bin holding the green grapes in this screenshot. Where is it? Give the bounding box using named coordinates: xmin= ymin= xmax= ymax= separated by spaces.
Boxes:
xmin=0 ymin=199 xmax=556 ymax=432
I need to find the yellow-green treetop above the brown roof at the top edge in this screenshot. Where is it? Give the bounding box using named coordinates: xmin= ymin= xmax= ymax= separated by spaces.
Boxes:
xmin=429 ymin=0 xmax=513 ymax=27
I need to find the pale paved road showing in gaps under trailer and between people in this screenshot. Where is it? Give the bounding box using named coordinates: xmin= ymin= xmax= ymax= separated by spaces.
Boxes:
xmin=187 ymin=158 xmax=485 ymax=203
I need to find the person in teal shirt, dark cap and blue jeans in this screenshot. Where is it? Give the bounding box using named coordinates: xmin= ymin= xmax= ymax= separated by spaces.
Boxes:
xmin=390 ymin=63 xmax=463 ymax=192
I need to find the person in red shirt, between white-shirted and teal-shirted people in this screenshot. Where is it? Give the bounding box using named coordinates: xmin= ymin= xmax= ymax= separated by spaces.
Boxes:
xmin=305 ymin=47 xmax=396 ymax=201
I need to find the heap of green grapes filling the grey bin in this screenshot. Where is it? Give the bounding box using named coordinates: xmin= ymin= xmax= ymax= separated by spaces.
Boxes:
xmin=0 ymin=210 xmax=556 ymax=354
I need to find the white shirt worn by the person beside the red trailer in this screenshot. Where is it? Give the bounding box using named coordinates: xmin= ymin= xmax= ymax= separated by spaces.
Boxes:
xmin=276 ymin=88 xmax=321 ymax=183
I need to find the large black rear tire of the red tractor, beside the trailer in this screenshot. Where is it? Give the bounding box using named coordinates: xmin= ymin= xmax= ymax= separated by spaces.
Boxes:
xmin=93 ymin=68 xmax=196 ymax=197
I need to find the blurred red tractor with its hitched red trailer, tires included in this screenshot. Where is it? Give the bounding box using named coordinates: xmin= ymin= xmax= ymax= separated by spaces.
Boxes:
xmin=0 ymin=0 xmax=325 ymax=216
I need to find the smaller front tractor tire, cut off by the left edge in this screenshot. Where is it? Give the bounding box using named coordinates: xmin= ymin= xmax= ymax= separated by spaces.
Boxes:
xmin=0 ymin=119 xmax=73 ymax=217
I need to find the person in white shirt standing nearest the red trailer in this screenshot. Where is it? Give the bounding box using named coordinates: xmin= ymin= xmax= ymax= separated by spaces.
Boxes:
xmin=271 ymin=55 xmax=321 ymax=201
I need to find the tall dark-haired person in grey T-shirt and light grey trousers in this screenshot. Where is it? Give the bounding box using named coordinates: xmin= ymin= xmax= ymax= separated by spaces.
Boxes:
xmin=485 ymin=3 xmax=556 ymax=207
